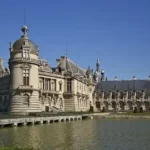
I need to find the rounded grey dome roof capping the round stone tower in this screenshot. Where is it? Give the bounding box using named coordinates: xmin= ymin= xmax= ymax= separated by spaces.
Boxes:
xmin=13 ymin=37 xmax=38 ymax=52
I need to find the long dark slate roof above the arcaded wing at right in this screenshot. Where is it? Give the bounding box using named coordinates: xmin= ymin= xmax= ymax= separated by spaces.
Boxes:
xmin=96 ymin=80 xmax=150 ymax=91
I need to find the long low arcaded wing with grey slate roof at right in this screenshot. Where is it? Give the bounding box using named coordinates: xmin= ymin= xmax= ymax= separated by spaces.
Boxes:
xmin=93 ymin=79 xmax=150 ymax=112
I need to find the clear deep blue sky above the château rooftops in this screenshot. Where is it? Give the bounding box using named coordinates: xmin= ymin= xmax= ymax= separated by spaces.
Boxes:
xmin=0 ymin=0 xmax=150 ymax=79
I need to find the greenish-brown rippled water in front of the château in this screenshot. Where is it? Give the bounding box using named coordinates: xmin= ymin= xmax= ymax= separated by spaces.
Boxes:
xmin=0 ymin=119 xmax=150 ymax=150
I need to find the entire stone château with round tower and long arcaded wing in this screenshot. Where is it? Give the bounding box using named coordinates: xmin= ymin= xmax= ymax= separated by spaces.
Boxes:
xmin=0 ymin=25 xmax=150 ymax=113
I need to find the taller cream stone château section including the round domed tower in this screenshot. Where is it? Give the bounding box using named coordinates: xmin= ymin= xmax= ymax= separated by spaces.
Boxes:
xmin=0 ymin=26 xmax=95 ymax=113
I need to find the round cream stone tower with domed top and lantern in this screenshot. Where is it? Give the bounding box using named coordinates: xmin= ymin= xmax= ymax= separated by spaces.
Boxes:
xmin=8 ymin=25 xmax=40 ymax=113
